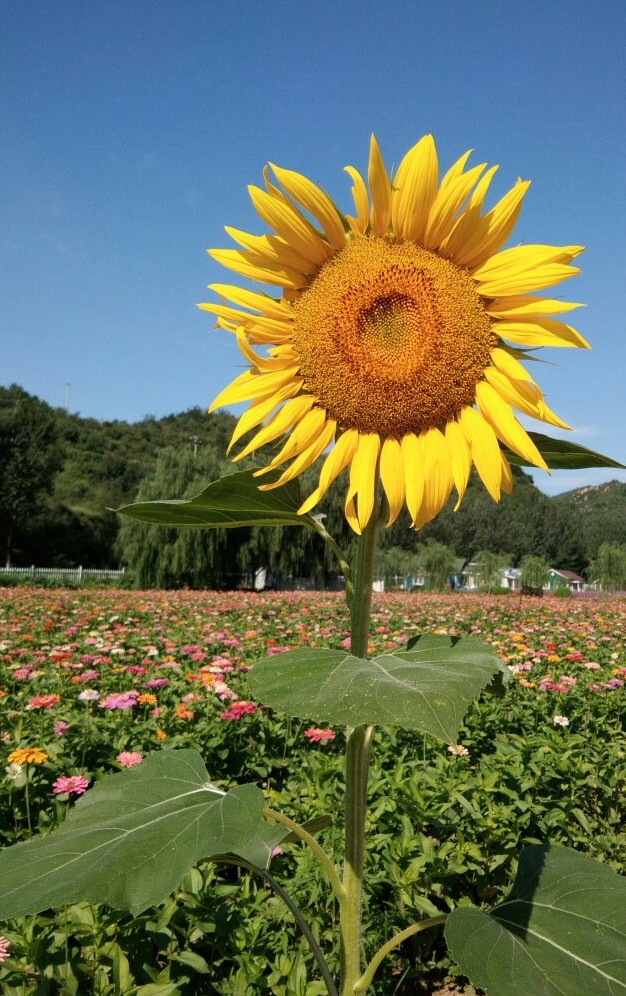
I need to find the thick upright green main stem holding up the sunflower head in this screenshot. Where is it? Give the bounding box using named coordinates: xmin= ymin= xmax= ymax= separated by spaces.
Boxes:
xmin=340 ymin=513 xmax=380 ymax=996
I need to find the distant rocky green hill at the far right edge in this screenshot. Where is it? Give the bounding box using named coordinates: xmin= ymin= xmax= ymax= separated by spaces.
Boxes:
xmin=550 ymin=481 xmax=626 ymax=559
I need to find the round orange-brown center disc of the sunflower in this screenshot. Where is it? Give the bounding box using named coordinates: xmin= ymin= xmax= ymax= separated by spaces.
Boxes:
xmin=292 ymin=236 xmax=496 ymax=438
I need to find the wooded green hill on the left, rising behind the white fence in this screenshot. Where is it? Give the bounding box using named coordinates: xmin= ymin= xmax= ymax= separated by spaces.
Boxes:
xmin=0 ymin=384 xmax=235 ymax=567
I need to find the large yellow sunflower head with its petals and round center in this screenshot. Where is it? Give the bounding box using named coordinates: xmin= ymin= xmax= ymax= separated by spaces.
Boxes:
xmin=200 ymin=135 xmax=587 ymax=533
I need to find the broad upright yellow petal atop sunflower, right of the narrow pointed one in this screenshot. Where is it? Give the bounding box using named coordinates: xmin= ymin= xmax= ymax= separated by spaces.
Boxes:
xmin=392 ymin=135 xmax=438 ymax=243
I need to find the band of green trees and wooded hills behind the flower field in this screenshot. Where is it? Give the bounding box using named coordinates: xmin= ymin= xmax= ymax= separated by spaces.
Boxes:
xmin=0 ymin=385 xmax=626 ymax=586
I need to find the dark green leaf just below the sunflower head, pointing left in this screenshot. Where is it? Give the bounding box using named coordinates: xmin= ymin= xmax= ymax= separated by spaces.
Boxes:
xmin=117 ymin=470 xmax=314 ymax=529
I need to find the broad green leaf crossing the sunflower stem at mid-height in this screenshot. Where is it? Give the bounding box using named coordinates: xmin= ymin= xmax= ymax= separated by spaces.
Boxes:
xmin=248 ymin=635 xmax=508 ymax=743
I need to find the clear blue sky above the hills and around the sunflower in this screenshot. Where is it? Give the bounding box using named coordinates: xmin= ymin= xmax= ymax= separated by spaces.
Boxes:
xmin=0 ymin=0 xmax=626 ymax=493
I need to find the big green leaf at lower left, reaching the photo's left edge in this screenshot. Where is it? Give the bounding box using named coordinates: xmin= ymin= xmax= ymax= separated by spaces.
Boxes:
xmin=0 ymin=750 xmax=285 ymax=919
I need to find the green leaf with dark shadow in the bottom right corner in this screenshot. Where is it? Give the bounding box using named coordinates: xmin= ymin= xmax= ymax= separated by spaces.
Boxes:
xmin=445 ymin=845 xmax=626 ymax=996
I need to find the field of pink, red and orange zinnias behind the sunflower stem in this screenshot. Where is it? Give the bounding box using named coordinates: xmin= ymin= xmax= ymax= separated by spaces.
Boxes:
xmin=0 ymin=588 xmax=626 ymax=996
